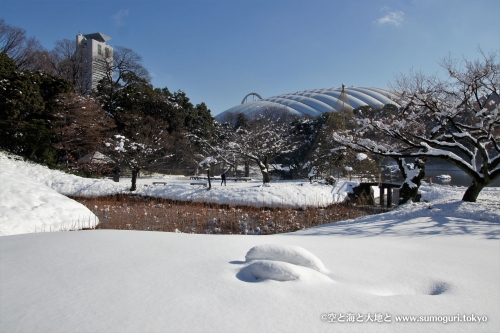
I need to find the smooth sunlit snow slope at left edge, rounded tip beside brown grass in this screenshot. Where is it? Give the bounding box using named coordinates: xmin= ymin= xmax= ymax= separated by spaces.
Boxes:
xmin=0 ymin=162 xmax=99 ymax=236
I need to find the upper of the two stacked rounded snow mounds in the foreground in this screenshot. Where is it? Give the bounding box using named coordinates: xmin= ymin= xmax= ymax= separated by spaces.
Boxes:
xmin=245 ymin=244 xmax=327 ymax=273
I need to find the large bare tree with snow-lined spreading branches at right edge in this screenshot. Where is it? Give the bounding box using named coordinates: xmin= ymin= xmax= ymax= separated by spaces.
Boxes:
xmin=333 ymin=50 xmax=500 ymax=202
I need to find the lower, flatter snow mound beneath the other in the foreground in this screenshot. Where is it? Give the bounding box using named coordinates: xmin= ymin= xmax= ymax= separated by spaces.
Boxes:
xmin=244 ymin=260 xmax=331 ymax=282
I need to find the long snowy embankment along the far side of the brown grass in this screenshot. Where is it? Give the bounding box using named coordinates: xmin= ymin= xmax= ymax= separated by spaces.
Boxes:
xmin=0 ymin=152 xmax=357 ymax=208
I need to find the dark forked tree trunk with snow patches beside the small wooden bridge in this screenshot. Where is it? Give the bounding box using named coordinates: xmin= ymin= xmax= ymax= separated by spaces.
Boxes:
xmin=389 ymin=158 xmax=427 ymax=205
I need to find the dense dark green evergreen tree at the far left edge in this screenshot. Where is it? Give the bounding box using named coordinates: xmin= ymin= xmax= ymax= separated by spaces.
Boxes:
xmin=0 ymin=52 xmax=72 ymax=163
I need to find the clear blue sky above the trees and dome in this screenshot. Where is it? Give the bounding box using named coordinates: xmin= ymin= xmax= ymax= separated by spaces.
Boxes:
xmin=0 ymin=0 xmax=500 ymax=115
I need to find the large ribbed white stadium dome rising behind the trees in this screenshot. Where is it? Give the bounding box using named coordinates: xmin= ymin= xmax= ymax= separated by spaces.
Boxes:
xmin=215 ymin=87 xmax=398 ymax=120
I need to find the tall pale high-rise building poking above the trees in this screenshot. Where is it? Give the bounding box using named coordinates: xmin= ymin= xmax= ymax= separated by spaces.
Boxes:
xmin=76 ymin=32 xmax=113 ymax=92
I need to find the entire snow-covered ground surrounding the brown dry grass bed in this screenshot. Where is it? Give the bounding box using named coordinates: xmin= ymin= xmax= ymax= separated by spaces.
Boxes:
xmin=0 ymin=154 xmax=500 ymax=332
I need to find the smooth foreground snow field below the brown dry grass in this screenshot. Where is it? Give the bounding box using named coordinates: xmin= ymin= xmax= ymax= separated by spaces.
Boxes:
xmin=0 ymin=222 xmax=500 ymax=332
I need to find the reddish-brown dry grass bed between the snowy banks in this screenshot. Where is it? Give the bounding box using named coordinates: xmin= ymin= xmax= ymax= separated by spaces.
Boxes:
xmin=73 ymin=195 xmax=385 ymax=235
